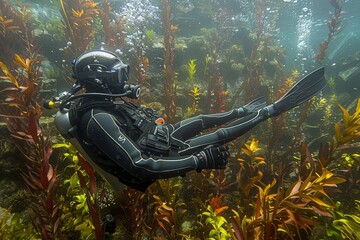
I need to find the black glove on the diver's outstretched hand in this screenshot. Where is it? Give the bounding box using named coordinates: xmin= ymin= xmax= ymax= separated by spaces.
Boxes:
xmin=195 ymin=145 xmax=230 ymax=171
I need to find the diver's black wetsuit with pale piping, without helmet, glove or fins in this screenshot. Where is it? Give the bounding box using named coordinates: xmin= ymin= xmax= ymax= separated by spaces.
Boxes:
xmin=77 ymin=98 xmax=268 ymax=191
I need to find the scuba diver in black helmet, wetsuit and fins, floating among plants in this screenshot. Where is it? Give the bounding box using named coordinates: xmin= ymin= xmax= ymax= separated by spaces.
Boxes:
xmin=44 ymin=50 xmax=326 ymax=191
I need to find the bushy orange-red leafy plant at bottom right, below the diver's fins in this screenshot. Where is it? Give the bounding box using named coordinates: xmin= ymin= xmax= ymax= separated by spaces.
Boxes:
xmin=232 ymin=161 xmax=344 ymax=239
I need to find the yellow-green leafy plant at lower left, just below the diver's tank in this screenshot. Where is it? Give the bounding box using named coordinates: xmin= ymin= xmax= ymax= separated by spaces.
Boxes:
xmin=53 ymin=143 xmax=105 ymax=239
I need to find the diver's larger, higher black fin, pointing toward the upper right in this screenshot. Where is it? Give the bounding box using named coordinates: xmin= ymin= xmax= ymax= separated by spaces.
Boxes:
xmin=269 ymin=67 xmax=327 ymax=115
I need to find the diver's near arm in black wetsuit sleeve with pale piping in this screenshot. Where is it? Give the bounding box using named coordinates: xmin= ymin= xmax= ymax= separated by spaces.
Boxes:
xmin=85 ymin=110 xmax=224 ymax=179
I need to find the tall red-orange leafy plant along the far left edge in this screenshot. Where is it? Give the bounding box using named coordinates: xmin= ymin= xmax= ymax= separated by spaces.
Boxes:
xmin=0 ymin=53 xmax=60 ymax=239
